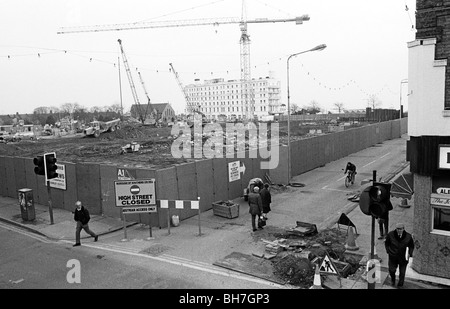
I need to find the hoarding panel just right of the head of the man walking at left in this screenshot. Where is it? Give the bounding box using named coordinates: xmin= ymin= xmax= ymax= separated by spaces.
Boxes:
xmin=75 ymin=163 xmax=102 ymax=215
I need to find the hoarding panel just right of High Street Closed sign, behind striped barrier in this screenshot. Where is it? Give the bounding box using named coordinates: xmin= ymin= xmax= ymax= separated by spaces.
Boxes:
xmin=156 ymin=167 xmax=178 ymax=227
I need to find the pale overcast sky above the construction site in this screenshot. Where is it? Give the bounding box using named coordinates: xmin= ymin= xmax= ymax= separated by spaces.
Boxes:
xmin=0 ymin=0 xmax=416 ymax=114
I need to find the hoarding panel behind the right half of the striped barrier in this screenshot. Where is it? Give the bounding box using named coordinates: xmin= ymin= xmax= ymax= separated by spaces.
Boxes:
xmin=176 ymin=162 xmax=198 ymax=220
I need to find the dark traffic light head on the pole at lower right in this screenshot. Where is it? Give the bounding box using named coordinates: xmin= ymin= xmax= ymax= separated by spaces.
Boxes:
xmin=359 ymin=182 xmax=393 ymax=218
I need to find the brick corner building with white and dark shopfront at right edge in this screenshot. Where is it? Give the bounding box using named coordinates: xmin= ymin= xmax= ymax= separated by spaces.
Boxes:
xmin=407 ymin=0 xmax=450 ymax=278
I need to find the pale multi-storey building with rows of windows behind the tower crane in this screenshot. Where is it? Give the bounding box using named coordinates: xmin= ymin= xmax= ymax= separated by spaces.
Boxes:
xmin=184 ymin=77 xmax=283 ymax=120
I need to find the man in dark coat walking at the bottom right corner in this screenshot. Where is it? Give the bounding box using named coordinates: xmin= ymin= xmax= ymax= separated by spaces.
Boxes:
xmin=384 ymin=223 xmax=414 ymax=287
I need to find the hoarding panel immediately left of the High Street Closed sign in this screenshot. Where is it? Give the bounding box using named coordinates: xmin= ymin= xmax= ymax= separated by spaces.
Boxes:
xmin=100 ymin=165 xmax=120 ymax=218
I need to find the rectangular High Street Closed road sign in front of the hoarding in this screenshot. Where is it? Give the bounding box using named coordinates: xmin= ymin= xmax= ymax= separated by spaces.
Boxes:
xmin=114 ymin=179 xmax=156 ymax=207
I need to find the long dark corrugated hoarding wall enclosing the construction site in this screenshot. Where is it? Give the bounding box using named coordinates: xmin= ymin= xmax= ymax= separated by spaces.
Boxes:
xmin=0 ymin=118 xmax=407 ymax=227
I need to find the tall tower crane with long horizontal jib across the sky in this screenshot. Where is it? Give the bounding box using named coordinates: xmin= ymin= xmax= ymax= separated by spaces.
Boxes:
xmin=57 ymin=0 xmax=310 ymax=118
